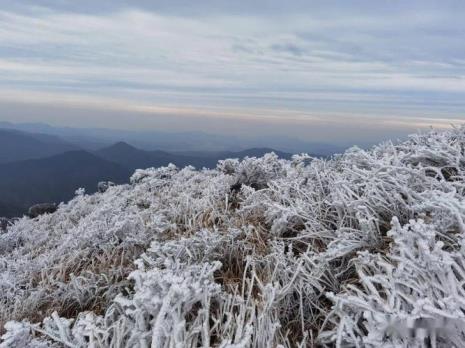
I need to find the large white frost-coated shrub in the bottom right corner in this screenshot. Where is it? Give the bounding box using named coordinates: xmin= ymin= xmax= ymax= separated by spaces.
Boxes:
xmin=322 ymin=218 xmax=465 ymax=347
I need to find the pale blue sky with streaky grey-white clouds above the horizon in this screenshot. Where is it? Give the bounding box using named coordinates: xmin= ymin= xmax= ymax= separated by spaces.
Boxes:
xmin=0 ymin=0 xmax=465 ymax=142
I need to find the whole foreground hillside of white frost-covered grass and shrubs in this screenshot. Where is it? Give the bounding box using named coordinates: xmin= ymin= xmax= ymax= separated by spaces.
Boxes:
xmin=0 ymin=129 xmax=465 ymax=348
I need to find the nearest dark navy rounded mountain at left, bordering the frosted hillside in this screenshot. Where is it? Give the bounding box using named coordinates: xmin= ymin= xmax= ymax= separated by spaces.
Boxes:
xmin=0 ymin=151 xmax=130 ymax=217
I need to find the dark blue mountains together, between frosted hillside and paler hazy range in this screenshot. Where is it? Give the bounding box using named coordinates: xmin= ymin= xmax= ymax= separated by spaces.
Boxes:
xmin=0 ymin=129 xmax=291 ymax=217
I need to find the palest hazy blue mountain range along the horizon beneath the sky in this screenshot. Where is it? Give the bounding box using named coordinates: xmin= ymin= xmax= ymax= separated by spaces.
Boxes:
xmin=0 ymin=121 xmax=344 ymax=156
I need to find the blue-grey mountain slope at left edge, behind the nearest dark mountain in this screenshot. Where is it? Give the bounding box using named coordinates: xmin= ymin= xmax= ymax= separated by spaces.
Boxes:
xmin=0 ymin=129 xmax=77 ymax=163
